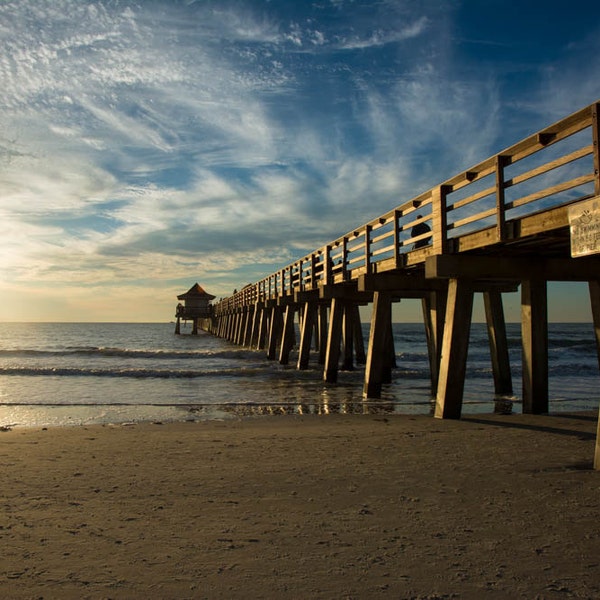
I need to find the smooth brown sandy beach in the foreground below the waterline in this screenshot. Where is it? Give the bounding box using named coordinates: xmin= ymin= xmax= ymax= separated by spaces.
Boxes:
xmin=0 ymin=413 xmax=600 ymax=600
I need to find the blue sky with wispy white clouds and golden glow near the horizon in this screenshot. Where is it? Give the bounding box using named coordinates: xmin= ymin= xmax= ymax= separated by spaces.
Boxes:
xmin=0 ymin=0 xmax=600 ymax=322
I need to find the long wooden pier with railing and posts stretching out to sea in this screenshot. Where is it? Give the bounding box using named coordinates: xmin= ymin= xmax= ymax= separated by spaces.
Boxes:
xmin=200 ymin=103 xmax=600 ymax=468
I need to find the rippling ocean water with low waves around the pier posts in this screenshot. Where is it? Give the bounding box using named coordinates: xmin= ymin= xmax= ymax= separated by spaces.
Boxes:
xmin=0 ymin=323 xmax=600 ymax=426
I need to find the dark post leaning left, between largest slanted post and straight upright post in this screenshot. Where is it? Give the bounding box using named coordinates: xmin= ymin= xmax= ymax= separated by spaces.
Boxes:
xmin=483 ymin=291 xmax=513 ymax=395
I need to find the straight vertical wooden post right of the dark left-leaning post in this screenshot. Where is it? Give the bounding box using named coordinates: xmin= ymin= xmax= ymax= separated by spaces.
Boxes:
xmin=521 ymin=279 xmax=548 ymax=414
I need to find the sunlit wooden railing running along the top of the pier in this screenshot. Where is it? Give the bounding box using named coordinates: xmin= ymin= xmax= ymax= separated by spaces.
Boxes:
xmin=214 ymin=103 xmax=600 ymax=314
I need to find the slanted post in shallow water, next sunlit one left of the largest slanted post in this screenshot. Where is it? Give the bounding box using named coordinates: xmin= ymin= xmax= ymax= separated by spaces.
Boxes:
xmin=363 ymin=292 xmax=392 ymax=398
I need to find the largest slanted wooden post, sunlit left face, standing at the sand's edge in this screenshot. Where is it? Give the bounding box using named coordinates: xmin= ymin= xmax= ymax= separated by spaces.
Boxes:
xmin=435 ymin=279 xmax=473 ymax=419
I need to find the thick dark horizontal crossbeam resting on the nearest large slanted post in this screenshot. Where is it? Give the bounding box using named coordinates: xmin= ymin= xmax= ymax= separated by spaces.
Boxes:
xmin=425 ymin=254 xmax=600 ymax=281
